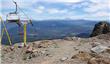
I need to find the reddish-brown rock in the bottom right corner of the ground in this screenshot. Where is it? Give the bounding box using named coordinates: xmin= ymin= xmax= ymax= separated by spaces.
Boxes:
xmin=87 ymin=57 xmax=110 ymax=64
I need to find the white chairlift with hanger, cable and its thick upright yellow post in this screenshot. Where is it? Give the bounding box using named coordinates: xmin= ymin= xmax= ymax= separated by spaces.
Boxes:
xmin=3 ymin=0 xmax=36 ymax=45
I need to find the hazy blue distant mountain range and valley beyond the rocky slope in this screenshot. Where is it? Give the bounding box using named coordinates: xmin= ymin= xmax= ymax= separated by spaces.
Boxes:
xmin=2 ymin=20 xmax=97 ymax=44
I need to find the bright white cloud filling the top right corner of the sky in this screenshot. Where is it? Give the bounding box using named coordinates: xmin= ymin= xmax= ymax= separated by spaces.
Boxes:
xmin=84 ymin=0 xmax=110 ymax=13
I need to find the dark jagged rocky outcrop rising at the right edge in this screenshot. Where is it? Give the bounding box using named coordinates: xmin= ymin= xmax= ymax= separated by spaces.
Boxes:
xmin=90 ymin=22 xmax=110 ymax=37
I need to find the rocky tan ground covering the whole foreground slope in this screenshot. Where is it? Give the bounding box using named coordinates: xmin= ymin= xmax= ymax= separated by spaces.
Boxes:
xmin=1 ymin=33 xmax=110 ymax=64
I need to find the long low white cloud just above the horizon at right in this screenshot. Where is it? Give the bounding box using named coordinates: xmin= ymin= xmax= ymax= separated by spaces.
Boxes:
xmin=67 ymin=11 xmax=110 ymax=20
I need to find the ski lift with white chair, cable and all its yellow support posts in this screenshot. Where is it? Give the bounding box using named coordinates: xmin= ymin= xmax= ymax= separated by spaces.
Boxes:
xmin=1 ymin=0 xmax=33 ymax=46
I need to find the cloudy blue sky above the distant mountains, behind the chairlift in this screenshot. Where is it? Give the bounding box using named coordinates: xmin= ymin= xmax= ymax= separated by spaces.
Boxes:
xmin=0 ymin=0 xmax=110 ymax=20
